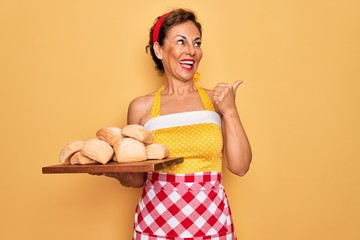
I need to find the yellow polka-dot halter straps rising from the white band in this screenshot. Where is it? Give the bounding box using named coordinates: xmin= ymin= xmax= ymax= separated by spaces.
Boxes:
xmin=150 ymin=85 xmax=215 ymax=118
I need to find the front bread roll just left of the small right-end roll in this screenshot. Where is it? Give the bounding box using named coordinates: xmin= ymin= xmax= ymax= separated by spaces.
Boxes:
xmin=114 ymin=138 xmax=147 ymax=163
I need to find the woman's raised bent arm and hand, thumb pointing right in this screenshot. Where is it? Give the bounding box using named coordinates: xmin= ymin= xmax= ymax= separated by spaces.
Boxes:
xmin=212 ymin=81 xmax=252 ymax=176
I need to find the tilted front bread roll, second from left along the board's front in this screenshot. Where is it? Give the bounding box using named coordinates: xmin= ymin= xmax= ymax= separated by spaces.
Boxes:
xmin=81 ymin=138 xmax=114 ymax=164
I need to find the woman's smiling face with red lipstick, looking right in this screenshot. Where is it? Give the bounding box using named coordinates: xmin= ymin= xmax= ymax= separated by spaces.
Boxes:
xmin=161 ymin=21 xmax=202 ymax=81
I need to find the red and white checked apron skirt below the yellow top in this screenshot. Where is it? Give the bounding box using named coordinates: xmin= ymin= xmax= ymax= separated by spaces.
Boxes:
xmin=133 ymin=172 xmax=236 ymax=240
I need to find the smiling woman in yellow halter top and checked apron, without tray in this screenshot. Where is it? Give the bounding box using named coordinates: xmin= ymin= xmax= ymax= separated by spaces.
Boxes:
xmin=107 ymin=9 xmax=251 ymax=239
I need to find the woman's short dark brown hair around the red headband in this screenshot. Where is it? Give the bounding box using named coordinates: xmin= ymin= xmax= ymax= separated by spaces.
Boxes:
xmin=146 ymin=8 xmax=202 ymax=73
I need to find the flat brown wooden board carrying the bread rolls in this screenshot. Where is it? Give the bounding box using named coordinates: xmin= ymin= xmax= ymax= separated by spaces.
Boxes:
xmin=42 ymin=157 xmax=184 ymax=174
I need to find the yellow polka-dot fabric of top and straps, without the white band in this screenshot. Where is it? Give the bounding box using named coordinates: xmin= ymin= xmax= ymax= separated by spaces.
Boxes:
xmin=148 ymin=87 xmax=223 ymax=174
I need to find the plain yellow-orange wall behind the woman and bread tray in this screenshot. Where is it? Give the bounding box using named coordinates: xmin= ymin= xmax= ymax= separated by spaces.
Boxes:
xmin=0 ymin=0 xmax=360 ymax=240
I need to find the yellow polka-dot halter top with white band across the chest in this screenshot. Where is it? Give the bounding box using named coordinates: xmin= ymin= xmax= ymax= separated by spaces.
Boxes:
xmin=145 ymin=86 xmax=223 ymax=174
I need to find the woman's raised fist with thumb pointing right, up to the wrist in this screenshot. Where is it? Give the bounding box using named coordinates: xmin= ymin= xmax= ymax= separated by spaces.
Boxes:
xmin=212 ymin=80 xmax=243 ymax=113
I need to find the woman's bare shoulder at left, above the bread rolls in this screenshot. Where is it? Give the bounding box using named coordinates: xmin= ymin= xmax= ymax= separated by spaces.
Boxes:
xmin=127 ymin=92 xmax=155 ymax=125
